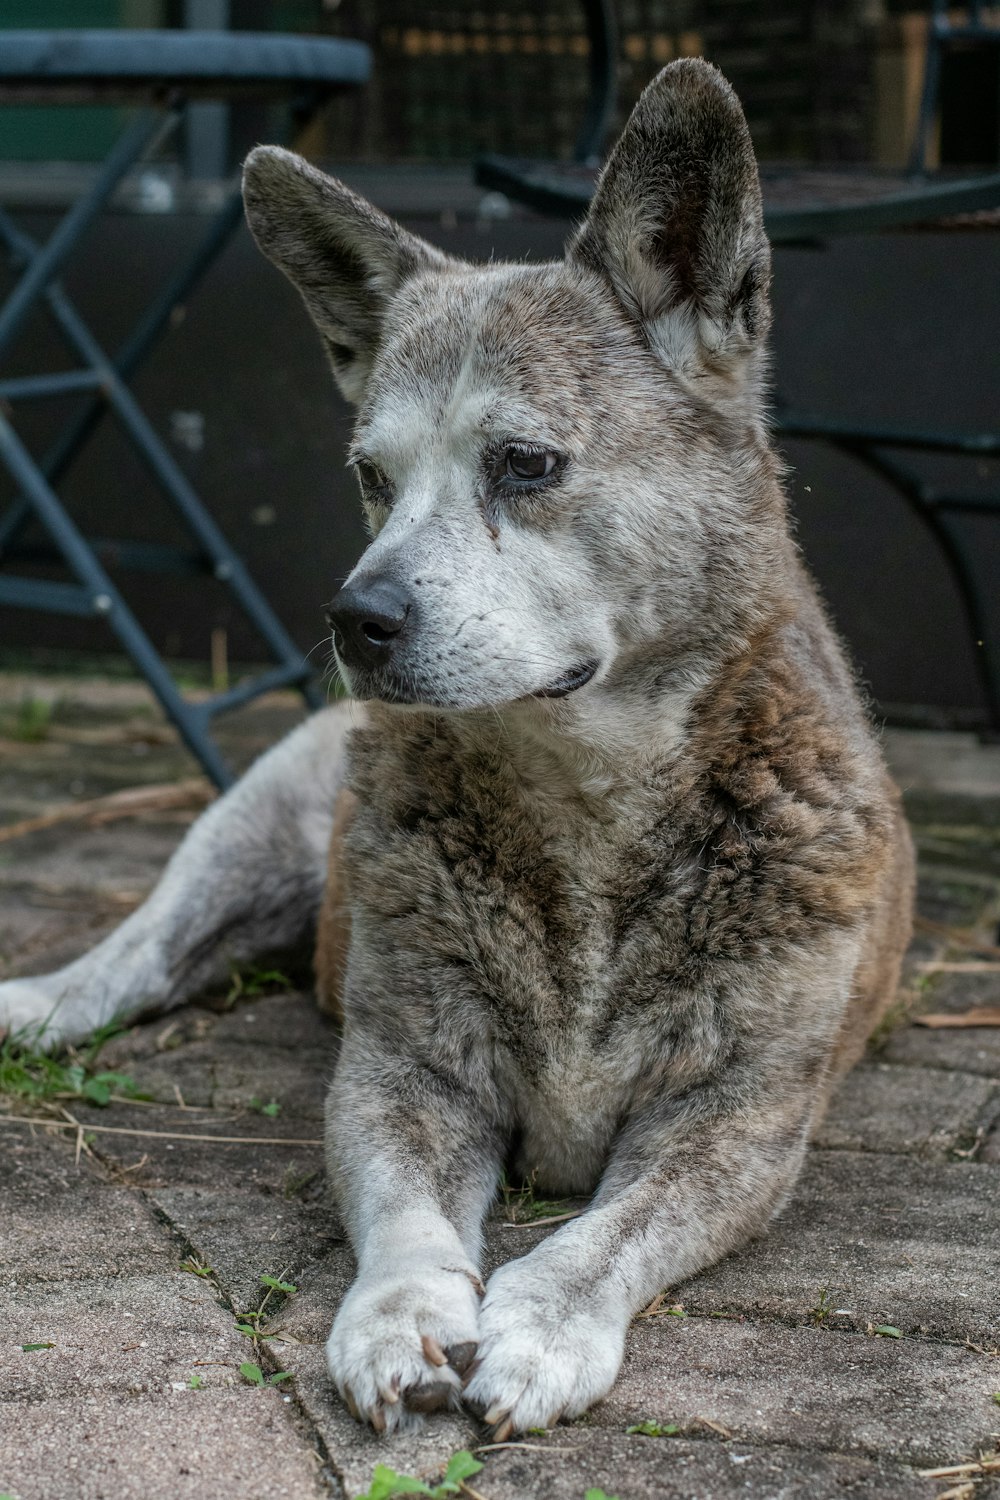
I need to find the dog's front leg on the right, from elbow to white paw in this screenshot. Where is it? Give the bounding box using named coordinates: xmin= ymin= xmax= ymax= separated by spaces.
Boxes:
xmin=466 ymin=1091 xmax=810 ymax=1442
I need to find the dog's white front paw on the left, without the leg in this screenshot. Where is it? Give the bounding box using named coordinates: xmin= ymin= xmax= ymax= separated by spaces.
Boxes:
xmin=327 ymin=1266 xmax=480 ymax=1433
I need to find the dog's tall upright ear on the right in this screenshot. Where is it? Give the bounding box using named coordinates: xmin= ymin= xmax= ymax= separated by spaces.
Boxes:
xmin=568 ymin=59 xmax=771 ymax=402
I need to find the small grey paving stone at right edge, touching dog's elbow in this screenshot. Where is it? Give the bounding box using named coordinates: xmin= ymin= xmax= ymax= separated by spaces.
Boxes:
xmin=814 ymin=1062 xmax=1000 ymax=1157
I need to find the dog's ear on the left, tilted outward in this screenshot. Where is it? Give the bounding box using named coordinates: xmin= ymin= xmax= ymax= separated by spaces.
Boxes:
xmin=243 ymin=146 xmax=448 ymax=402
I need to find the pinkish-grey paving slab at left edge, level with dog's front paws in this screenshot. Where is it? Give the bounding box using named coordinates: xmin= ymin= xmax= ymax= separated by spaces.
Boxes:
xmin=0 ymin=1271 xmax=242 ymax=1398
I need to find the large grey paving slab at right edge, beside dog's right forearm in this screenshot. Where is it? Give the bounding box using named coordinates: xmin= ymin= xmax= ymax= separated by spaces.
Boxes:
xmin=670 ymin=1151 xmax=1000 ymax=1346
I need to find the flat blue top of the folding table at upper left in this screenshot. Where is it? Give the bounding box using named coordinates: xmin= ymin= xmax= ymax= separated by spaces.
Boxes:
xmin=0 ymin=30 xmax=372 ymax=99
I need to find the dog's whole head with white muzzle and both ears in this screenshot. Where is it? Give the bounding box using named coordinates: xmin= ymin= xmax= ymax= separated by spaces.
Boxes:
xmin=244 ymin=60 xmax=784 ymax=729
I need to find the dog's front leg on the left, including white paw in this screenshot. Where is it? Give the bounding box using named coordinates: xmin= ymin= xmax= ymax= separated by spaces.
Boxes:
xmin=327 ymin=1019 xmax=502 ymax=1431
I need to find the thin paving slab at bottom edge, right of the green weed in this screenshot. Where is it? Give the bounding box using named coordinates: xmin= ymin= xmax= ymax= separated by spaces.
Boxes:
xmin=472 ymin=1428 xmax=947 ymax=1500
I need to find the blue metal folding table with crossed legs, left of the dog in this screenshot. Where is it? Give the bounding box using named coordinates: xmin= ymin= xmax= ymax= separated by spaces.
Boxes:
xmin=0 ymin=32 xmax=370 ymax=788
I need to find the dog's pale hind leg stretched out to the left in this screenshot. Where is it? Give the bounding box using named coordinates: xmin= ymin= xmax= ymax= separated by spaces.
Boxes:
xmin=0 ymin=707 xmax=358 ymax=1047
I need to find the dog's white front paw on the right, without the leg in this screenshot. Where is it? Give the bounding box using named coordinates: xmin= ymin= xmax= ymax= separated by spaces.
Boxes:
xmin=465 ymin=1253 xmax=628 ymax=1442
